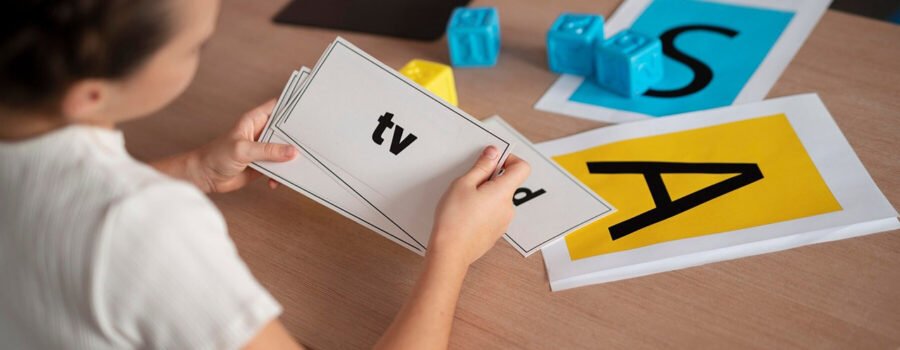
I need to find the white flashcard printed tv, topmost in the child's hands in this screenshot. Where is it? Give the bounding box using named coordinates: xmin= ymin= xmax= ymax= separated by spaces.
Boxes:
xmin=273 ymin=38 xmax=512 ymax=249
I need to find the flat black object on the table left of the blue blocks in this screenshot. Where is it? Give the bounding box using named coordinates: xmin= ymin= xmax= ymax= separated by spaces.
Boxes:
xmin=273 ymin=0 xmax=470 ymax=40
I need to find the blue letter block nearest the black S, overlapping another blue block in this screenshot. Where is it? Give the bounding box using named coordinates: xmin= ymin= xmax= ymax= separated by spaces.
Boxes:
xmin=594 ymin=30 xmax=663 ymax=97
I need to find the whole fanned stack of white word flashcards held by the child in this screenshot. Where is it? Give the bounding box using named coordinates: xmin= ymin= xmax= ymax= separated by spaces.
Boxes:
xmin=253 ymin=38 xmax=612 ymax=256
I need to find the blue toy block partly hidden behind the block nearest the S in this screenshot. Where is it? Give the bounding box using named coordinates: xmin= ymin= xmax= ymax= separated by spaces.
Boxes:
xmin=547 ymin=13 xmax=603 ymax=76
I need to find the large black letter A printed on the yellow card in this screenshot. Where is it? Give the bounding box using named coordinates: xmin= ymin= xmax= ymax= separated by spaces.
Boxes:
xmin=587 ymin=162 xmax=763 ymax=240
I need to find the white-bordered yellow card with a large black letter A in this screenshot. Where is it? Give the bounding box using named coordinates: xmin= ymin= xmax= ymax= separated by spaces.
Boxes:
xmin=537 ymin=94 xmax=900 ymax=291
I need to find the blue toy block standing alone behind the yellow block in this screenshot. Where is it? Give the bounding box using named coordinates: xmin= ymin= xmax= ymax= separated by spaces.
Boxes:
xmin=447 ymin=7 xmax=500 ymax=67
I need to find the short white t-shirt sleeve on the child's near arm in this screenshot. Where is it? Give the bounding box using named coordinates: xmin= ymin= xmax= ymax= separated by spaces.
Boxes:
xmin=92 ymin=183 xmax=281 ymax=349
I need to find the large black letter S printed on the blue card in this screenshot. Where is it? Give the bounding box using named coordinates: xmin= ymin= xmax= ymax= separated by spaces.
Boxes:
xmin=644 ymin=25 xmax=738 ymax=97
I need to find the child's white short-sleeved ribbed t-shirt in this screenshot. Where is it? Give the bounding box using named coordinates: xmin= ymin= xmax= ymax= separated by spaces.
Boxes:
xmin=0 ymin=126 xmax=281 ymax=349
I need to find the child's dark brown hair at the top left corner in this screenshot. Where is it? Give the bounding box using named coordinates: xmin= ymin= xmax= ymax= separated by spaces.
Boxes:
xmin=0 ymin=0 xmax=171 ymax=109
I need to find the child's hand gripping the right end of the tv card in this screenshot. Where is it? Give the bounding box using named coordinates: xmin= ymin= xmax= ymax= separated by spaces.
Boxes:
xmin=427 ymin=146 xmax=531 ymax=268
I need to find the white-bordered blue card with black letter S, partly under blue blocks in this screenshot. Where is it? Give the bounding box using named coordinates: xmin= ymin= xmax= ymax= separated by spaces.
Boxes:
xmin=534 ymin=0 xmax=831 ymax=123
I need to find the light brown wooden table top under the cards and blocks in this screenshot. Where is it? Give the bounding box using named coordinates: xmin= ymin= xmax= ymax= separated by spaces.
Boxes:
xmin=124 ymin=0 xmax=900 ymax=349
